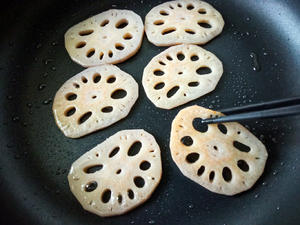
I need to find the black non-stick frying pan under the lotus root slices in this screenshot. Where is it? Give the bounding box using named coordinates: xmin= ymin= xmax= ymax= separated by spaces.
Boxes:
xmin=0 ymin=0 xmax=300 ymax=225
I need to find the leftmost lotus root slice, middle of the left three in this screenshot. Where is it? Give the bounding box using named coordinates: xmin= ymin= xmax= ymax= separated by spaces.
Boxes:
xmin=52 ymin=65 xmax=138 ymax=138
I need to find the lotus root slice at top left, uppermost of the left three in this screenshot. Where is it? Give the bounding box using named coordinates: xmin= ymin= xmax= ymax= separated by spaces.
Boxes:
xmin=65 ymin=9 xmax=144 ymax=67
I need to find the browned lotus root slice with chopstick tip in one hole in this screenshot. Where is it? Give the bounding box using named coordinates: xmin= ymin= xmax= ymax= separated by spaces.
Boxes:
xmin=170 ymin=105 xmax=268 ymax=195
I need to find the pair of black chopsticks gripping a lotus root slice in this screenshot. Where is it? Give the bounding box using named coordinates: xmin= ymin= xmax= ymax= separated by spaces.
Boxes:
xmin=202 ymin=97 xmax=300 ymax=124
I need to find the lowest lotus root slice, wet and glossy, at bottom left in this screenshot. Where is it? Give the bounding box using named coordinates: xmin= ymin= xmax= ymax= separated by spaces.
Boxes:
xmin=68 ymin=130 xmax=162 ymax=216
